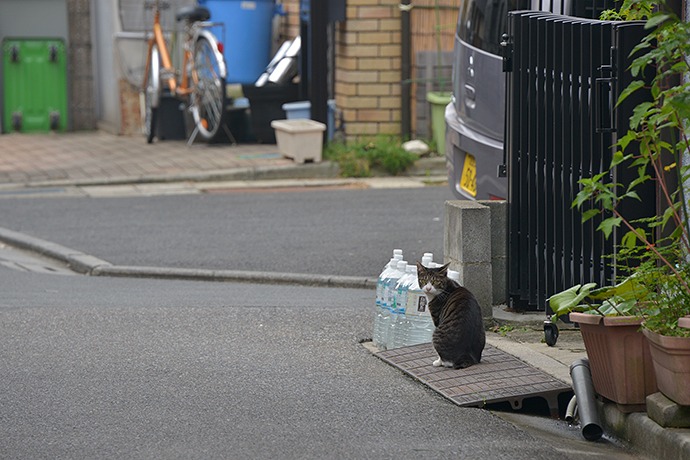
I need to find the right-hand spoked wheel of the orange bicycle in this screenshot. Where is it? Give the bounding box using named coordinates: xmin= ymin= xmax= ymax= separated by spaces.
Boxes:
xmin=190 ymin=35 xmax=226 ymax=141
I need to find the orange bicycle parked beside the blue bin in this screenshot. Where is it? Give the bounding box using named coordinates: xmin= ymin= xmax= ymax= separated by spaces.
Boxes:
xmin=142 ymin=0 xmax=227 ymax=144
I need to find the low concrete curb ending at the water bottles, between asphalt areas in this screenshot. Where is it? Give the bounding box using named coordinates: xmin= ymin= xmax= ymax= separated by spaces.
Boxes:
xmin=0 ymin=227 xmax=377 ymax=289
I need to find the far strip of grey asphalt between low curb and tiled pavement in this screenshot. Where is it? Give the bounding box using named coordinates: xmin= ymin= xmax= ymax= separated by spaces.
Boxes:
xmin=0 ymin=186 xmax=452 ymax=277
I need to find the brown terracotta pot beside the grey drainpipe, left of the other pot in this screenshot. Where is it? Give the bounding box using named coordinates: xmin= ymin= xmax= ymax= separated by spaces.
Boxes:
xmin=570 ymin=312 xmax=658 ymax=412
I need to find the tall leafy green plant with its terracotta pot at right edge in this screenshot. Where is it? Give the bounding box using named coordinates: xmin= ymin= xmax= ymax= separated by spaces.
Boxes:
xmin=573 ymin=0 xmax=690 ymax=405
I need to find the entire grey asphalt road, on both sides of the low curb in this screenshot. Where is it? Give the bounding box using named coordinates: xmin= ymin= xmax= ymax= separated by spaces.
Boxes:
xmin=0 ymin=188 xmax=630 ymax=460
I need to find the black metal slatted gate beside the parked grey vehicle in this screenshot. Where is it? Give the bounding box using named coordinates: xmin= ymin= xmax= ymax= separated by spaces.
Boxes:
xmin=504 ymin=11 xmax=654 ymax=310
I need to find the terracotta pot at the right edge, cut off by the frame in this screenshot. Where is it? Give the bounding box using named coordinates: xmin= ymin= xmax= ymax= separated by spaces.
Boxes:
xmin=643 ymin=329 xmax=690 ymax=406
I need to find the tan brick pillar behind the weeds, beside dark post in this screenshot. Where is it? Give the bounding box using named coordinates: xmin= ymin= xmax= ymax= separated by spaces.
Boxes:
xmin=335 ymin=0 xmax=401 ymax=138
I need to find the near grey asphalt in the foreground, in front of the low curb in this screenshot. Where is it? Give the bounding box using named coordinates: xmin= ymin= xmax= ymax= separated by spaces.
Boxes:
xmin=0 ymin=267 xmax=580 ymax=459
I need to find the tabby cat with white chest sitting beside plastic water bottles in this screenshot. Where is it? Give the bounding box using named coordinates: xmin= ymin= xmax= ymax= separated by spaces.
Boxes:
xmin=417 ymin=262 xmax=486 ymax=369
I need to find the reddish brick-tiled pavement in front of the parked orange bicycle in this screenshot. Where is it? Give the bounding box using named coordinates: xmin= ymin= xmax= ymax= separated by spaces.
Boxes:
xmin=0 ymin=131 xmax=295 ymax=186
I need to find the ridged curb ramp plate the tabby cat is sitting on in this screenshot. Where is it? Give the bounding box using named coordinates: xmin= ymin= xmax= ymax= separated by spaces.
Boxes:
xmin=375 ymin=343 xmax=572 ymax=416
